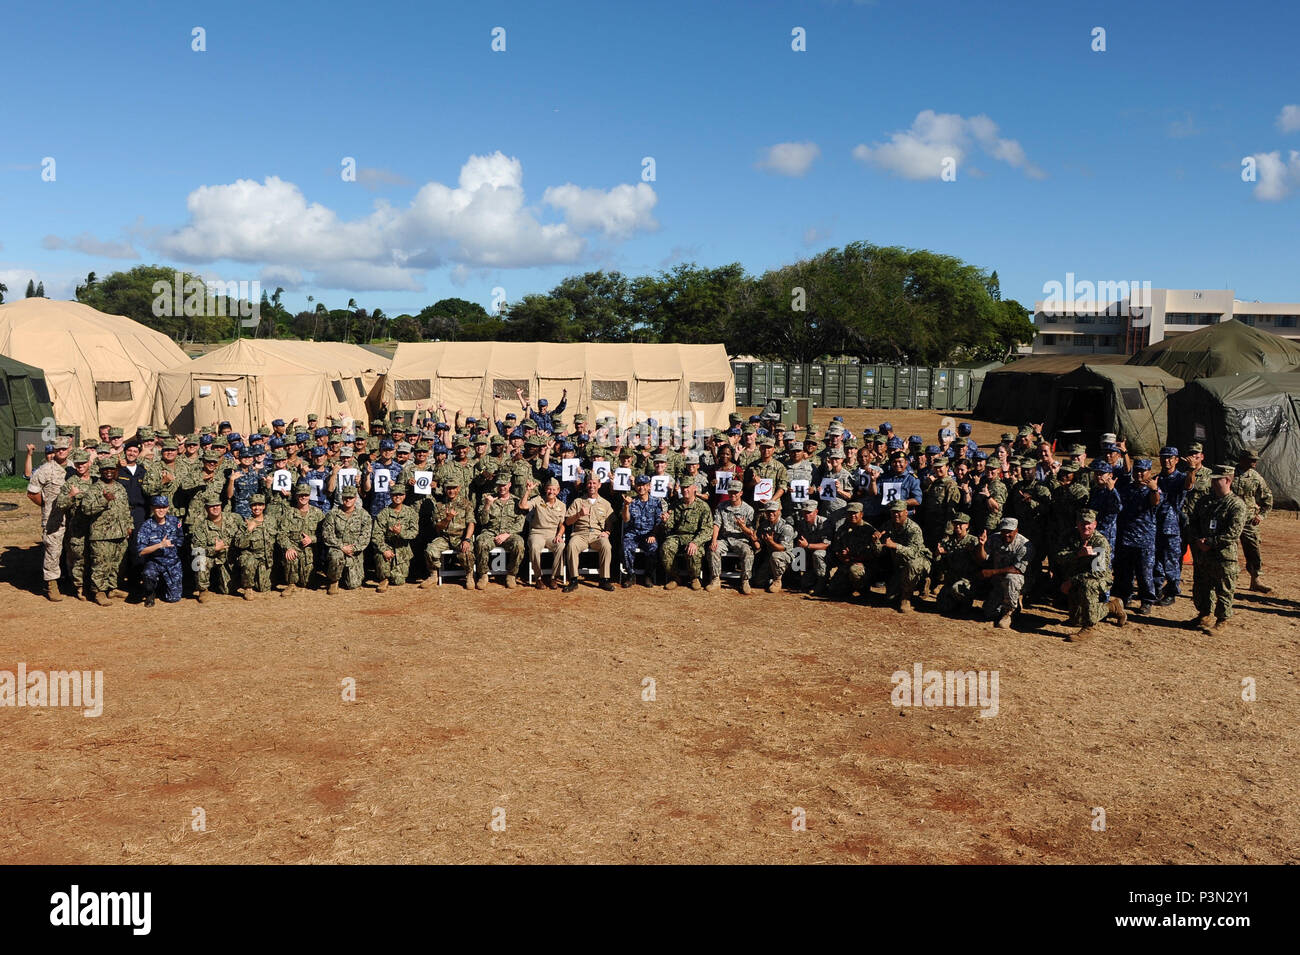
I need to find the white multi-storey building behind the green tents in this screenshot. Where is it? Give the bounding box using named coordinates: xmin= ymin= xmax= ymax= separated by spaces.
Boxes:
xmin=1034 ymin=288 xmax=1300 ymax=355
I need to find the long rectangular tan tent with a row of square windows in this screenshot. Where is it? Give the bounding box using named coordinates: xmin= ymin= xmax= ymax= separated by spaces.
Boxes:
xmin=384 ymin=342 xmax=736 ymax=430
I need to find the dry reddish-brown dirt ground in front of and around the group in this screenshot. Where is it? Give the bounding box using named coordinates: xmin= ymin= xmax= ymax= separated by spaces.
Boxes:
xmin=0 ymin=412 xmax=1300 ymax=863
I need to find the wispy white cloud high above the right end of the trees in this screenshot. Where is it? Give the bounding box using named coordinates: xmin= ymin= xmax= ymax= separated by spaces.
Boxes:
xmin=853 ymin=109 xmax=1047 ymax=179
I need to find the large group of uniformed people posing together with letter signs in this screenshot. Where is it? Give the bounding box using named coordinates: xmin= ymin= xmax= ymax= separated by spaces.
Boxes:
xmin=29 ymin=395 xmax=1273 ymax=639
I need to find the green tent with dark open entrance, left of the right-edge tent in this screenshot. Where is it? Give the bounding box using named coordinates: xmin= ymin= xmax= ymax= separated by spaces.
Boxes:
xmin=1043 ymin=363 xmax=1183 ymax=457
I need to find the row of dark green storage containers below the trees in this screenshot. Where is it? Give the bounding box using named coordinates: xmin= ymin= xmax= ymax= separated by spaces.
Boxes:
xmin=732 ymin=361 xmax=988 ymax=411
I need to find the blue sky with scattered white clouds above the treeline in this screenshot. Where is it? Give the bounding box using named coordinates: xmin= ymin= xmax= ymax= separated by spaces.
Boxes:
xmin=0 ymin=0 xmax=1300 ymax=314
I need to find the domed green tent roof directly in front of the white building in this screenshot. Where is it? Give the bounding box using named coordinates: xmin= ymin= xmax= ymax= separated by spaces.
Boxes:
xmin=1128 ymin=320 xmax=1300 ymax=381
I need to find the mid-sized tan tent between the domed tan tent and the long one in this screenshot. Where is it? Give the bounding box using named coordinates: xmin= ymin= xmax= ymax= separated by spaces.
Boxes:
xmin=153 ymin=338 xmax=389 ymax=434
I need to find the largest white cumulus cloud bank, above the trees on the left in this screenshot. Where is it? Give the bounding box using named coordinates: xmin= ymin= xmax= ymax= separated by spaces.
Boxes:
xmin=155 ymin=152 xmax=658 ymax=291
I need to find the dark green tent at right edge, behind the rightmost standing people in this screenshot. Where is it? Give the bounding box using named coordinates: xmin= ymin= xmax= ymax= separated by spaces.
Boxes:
xmin=1169 ymin=370 xmax=1300 ymax=508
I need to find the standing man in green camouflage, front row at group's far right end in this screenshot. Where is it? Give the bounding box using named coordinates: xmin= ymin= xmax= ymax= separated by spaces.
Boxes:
xmin=1188 ymin=465 xmax=1251 ymax=630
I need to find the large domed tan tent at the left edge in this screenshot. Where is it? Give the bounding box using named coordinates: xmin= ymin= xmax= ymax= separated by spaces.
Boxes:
xmin=0 ymin=299 xmax=187 ymax=435
